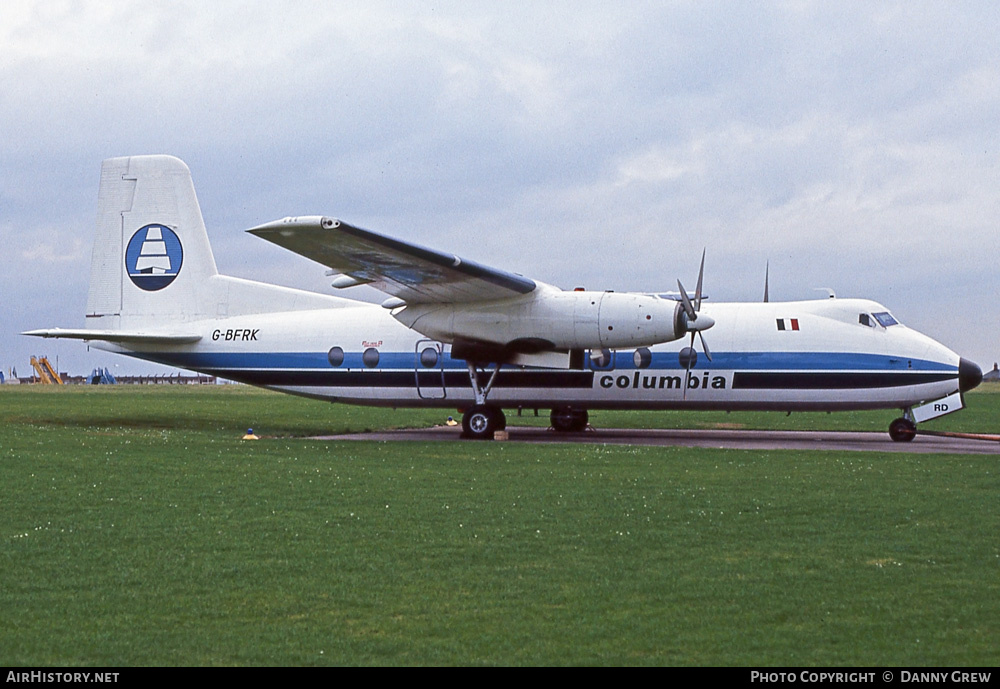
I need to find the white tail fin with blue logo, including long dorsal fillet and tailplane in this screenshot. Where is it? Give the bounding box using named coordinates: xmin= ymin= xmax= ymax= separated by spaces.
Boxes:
xmin=82 ymin=155 xmax=348 ymax=334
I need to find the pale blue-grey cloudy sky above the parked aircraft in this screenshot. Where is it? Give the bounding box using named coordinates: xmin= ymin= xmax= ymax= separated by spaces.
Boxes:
xmin=0 ymin=0 xmax=1000 ymax=375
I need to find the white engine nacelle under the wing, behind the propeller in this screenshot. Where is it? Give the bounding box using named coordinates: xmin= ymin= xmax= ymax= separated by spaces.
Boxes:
xmin=393 ymin=285 xmax=687 ymax=352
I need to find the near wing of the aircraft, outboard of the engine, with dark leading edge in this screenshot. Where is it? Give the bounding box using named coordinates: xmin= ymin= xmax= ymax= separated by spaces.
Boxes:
xmin=247 ymin=215 xmax=536 ymax=304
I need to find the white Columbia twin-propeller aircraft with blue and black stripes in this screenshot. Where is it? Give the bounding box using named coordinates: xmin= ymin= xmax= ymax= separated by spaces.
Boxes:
xmin=25 ymin=156 xmax=982 ymax=440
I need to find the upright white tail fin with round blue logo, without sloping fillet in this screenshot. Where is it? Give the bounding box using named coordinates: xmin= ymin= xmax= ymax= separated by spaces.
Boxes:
xmin=87 ymin=155 xmax=218 ymax=330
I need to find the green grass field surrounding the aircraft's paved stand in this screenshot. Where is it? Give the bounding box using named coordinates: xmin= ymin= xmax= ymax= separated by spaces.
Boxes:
xmin=0 ymin=386 xmax=1000 ymax=666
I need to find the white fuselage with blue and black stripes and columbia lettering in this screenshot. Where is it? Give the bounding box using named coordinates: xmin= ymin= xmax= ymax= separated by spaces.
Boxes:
xmin=94 ymin=292 xmax=959 ymax=411
